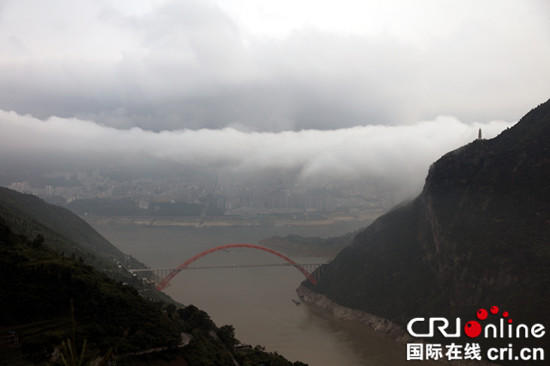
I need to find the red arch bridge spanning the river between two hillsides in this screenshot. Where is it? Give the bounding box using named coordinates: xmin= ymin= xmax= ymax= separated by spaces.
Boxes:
xmin=129 ymin=244 xmax=326 ymax=290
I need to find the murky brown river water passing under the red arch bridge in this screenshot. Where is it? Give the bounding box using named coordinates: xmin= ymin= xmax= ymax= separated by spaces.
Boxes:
xmin=89 ymin=220 xmax=418 ymax=366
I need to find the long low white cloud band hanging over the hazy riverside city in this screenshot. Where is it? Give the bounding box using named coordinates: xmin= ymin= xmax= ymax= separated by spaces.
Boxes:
xmin=0 ymin=110 xmax=512 ymax=200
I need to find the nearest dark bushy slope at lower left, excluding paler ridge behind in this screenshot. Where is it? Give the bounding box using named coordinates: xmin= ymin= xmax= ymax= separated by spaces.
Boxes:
xmin=0 ymin=218 xmax=304 ymax=366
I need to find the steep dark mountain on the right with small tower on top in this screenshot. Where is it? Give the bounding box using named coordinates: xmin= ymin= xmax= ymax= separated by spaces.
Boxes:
xmin=303 ymin=101 xmax=550 ymax=325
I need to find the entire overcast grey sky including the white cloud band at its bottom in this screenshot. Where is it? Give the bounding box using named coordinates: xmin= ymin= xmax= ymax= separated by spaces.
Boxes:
xmin=0 ymin=0 xmax=550 ymax=197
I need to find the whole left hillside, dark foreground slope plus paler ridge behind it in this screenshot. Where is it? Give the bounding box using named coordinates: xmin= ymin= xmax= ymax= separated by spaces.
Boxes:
xmin=0 ymin=188 xmax=306 ymax=366
